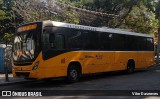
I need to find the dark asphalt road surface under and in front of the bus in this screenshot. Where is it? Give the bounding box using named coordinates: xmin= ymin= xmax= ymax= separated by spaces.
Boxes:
xmin=0 ymin=66 xmax=160 ymax=99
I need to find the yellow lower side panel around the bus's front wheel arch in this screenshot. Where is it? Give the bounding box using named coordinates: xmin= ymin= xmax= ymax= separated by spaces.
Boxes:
xmin=37 ymin=52 xmax=85 ymax=78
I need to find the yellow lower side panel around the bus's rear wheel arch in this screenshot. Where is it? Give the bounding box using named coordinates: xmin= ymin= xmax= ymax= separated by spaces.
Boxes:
xmin=112 ymin=51 xmax=154 ymax=71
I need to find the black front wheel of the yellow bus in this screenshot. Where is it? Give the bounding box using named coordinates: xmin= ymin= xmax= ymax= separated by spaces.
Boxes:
xmin=67 ymin=65 xmax=81 ymax=83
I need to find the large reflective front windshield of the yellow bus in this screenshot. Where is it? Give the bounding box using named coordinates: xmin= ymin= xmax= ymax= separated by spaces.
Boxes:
xmin=13 ymin=32 xmax=35 ymax=61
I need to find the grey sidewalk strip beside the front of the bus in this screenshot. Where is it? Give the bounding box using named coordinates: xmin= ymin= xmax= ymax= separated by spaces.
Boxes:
xmin=0 ymin=74 xmax=31 ymax=86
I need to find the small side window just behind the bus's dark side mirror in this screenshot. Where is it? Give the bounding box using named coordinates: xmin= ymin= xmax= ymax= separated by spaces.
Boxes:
xmin=55 ymin=34 xmax=65 ymax=49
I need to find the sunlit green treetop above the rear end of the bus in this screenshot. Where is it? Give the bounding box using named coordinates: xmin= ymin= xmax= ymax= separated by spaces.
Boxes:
xmin=120 ymin=5 xmax=158 ymax=34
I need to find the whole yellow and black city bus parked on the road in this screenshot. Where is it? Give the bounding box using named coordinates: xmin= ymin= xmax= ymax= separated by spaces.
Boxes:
xmin=13 ymin=21 xmax=154 ymax=82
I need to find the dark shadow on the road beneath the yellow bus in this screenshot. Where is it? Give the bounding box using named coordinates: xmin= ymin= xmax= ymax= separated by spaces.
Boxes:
xmin=12 ymin=69 xmax=151 ymax=90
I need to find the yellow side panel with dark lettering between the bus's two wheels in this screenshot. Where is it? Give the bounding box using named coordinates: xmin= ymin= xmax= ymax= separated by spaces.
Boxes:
xmin=82 ymin=51 xmax=114 ymax=74
